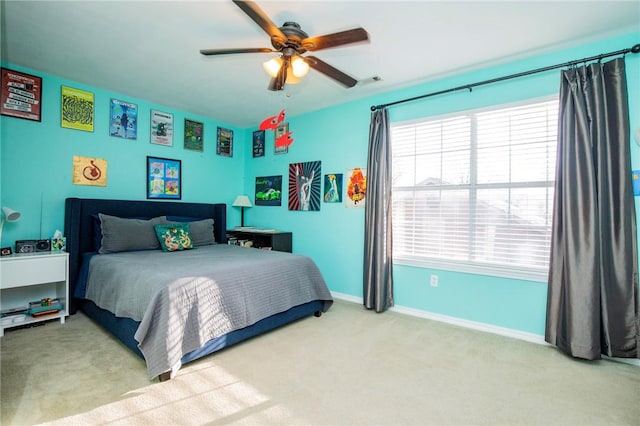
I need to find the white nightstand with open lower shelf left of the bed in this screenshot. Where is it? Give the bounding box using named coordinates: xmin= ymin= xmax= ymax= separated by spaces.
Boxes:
xmin=0 ymin=252 xmax=69 ymax=336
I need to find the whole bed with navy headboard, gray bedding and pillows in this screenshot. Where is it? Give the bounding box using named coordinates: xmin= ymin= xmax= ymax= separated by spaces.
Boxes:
xmin=65 ymin=198 xmax=333 ymax=381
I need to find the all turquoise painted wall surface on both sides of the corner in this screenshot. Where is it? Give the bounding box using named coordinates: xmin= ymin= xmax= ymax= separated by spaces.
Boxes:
xmin=0 ymin=32 xmax=640 ymax=335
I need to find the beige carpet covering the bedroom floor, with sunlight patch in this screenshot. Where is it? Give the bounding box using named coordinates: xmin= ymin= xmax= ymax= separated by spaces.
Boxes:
xmin=1 ymin=301 xmax=640 ymax=426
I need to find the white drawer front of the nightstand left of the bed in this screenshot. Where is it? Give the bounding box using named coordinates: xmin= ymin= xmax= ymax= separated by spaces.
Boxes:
xmin=0 ymin=256 xmax=67 ymax=289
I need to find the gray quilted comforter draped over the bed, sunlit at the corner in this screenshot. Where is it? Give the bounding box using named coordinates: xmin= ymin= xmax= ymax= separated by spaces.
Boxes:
xmin=86 ymin=244 xmax=332 ymax=377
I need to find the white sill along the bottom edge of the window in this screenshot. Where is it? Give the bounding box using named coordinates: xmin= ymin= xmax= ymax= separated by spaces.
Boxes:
xmin=393 ymin=256 xmax=548 ymax=284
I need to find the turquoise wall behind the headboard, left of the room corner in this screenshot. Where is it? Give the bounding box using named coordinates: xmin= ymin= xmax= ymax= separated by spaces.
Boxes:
xmin=0 ymin=71 xmax=247 ymax=247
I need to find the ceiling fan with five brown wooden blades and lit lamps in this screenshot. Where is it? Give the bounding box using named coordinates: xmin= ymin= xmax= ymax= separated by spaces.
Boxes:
xmin=200 ymin=0 xmax=369 ymax=91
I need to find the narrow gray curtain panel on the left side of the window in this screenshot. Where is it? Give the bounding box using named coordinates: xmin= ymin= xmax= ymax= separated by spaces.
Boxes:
xmin=363 ymin=108 xmax=393 ymax=312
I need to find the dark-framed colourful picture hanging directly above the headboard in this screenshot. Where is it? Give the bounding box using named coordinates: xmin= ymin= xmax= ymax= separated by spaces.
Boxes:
xmin=146 ymin=156 xmax=182 ymax=200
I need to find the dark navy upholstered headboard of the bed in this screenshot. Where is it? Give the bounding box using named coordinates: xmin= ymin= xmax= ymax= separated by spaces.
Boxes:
xmin=64 ymin=198 xmax=227 ymax=314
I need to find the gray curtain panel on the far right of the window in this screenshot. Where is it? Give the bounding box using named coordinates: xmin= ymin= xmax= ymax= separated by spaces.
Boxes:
xmin=545 ymin=58 xmax=640 ymax=359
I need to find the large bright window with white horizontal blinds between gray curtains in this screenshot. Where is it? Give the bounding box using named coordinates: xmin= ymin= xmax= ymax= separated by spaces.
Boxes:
xmin=391 ymin=99 xmax=558 ymax=281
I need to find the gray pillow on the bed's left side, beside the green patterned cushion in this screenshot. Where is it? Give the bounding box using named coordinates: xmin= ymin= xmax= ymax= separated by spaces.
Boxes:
xmin=98 ymin=213 xmax=167 ymax=254
